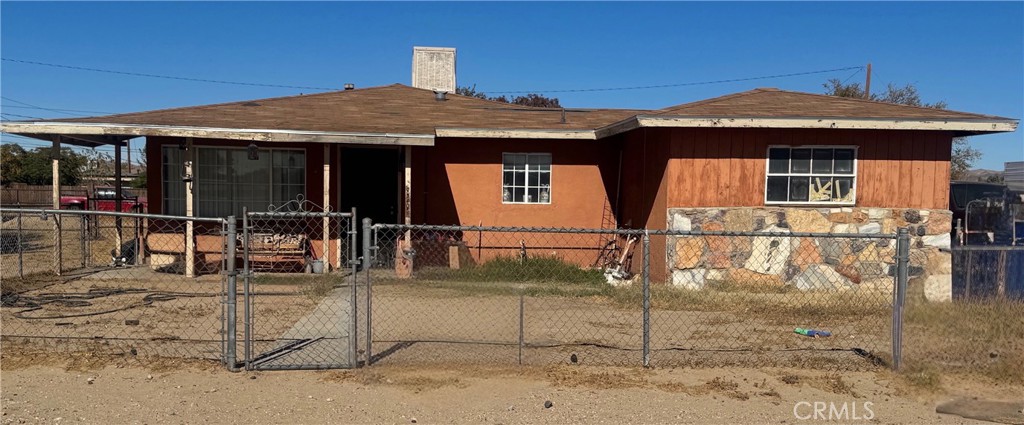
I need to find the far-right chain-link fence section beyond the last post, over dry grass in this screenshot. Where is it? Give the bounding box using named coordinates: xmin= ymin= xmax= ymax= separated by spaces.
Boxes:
xmin=903 ymin=246 xmax=1024 ymax=383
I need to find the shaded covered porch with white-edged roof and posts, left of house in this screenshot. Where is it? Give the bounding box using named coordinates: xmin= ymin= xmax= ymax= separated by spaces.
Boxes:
xmin=2 ymin=122 xmax=434 ymax=278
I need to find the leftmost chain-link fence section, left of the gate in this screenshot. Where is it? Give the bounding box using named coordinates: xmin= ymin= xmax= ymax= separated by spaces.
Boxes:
xmin=0 ymin=209 xmax=226 ymax=359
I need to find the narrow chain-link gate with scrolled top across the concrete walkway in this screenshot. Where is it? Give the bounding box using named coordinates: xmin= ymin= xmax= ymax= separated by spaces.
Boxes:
xmin=243 ymin=202 xmax=358 ymax=370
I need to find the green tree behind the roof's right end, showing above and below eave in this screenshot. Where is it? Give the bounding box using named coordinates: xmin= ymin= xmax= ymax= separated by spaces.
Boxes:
xmin=823 ymin=79 xmax=981 ymax=180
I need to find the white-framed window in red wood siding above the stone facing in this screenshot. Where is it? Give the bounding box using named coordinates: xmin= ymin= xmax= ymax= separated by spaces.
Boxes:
xmin=765 ymin=146 xmax=857 ymax=205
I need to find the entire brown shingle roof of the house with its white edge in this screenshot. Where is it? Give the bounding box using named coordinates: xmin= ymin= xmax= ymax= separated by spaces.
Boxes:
xmin=12 ymin=84 xmax=1017 ymax=144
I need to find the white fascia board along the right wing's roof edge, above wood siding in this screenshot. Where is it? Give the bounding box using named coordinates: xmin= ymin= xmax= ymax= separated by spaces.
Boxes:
xmin=637 ymin=115 xmax=1018 ymax=133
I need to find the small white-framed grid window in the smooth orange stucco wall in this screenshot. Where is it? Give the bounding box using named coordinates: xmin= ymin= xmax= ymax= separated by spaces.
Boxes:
xmin=502 ymin=153 xmax=551 ymax=204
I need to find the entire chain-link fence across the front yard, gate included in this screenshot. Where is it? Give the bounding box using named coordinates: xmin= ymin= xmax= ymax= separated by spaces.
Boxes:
xmin=6 ymin=209 xmax=1024 ymax=378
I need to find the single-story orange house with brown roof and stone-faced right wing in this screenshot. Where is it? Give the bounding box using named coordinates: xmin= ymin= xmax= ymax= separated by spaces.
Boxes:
xmin=2 ymin=48 xmax=1018 ymax=286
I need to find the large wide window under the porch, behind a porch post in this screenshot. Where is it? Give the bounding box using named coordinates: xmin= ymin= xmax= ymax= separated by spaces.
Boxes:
xmin=163 ymin=146 xmax=306 ymax=217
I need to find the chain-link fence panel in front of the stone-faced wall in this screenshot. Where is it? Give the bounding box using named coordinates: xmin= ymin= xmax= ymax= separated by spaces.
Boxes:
xmin=650 ymin=227 xmax=897 ymax=369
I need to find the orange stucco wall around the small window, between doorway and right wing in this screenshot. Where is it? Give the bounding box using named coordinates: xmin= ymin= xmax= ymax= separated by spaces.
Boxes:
xmin=413 ymin=138 xmax=618 ymax=228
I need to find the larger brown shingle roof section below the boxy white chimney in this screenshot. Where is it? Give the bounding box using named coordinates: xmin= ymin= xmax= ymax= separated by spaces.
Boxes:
xmin=58 ymin=84 xmax=644 ymax=134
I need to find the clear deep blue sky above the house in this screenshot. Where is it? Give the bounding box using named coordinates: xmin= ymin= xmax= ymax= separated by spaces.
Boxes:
xmin=0 ymin=1 xmax=1024 ymax=169
